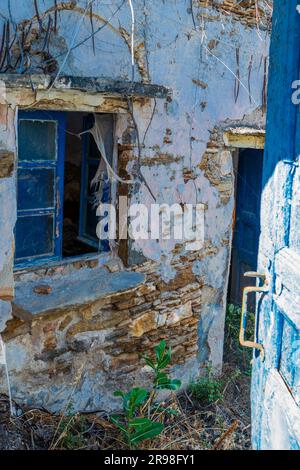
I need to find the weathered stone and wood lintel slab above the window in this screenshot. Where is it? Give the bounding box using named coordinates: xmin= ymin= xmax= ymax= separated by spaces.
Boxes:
xmin=1 ymin=74 xmax=171 ymax=113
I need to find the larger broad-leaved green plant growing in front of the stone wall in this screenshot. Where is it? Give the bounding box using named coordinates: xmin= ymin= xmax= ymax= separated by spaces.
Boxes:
xmin=110 ymin=340 xmax=181 ymax=448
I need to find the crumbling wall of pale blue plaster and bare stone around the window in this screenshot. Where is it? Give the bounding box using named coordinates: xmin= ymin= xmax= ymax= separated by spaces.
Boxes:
xmin=0 ymin=0 xmax=269 ymax=411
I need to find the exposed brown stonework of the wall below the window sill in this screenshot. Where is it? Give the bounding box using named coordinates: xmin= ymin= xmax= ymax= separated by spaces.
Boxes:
xmin=3 ymin=252 xmax=204 ymax=411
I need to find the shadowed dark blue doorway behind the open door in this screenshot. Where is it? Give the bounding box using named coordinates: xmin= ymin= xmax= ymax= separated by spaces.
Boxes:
xmin=227 ymin=149 xmax=263 ymax=311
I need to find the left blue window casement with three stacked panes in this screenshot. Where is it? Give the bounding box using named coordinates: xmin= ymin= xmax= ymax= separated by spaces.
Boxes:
xmin=15 ymin=111 xmax=66 ymax=266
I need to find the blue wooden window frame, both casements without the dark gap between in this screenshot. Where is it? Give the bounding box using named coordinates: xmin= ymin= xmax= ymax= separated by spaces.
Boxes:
xmin=15 ymin=111 xmax=113 ymax=267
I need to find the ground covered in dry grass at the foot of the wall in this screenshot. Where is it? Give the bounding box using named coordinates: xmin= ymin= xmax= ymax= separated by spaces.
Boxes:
xmin=0 ymin=304 xmax=251 ymax=450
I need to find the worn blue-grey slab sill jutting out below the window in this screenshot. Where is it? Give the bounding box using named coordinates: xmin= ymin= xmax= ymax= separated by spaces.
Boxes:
xmin=13 ymin=268 xmax=145 ymax=321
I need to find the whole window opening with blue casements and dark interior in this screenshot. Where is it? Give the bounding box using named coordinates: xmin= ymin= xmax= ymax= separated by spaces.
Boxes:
xmin=15 ymin=111 xmax=113 ymax=266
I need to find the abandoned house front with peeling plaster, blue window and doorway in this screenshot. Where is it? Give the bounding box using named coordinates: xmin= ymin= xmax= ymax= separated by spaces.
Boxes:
xmin=0 ymin=0 xmax=270 ymax=411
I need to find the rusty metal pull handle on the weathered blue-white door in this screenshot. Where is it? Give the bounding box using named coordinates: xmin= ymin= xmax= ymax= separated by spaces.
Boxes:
xmin=239 ymin=271 xmax=269 ymax=361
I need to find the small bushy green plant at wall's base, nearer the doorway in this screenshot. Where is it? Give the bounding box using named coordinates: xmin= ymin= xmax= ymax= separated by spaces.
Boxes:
xmin=189 ymin=366 xmax=224 ymax=405
